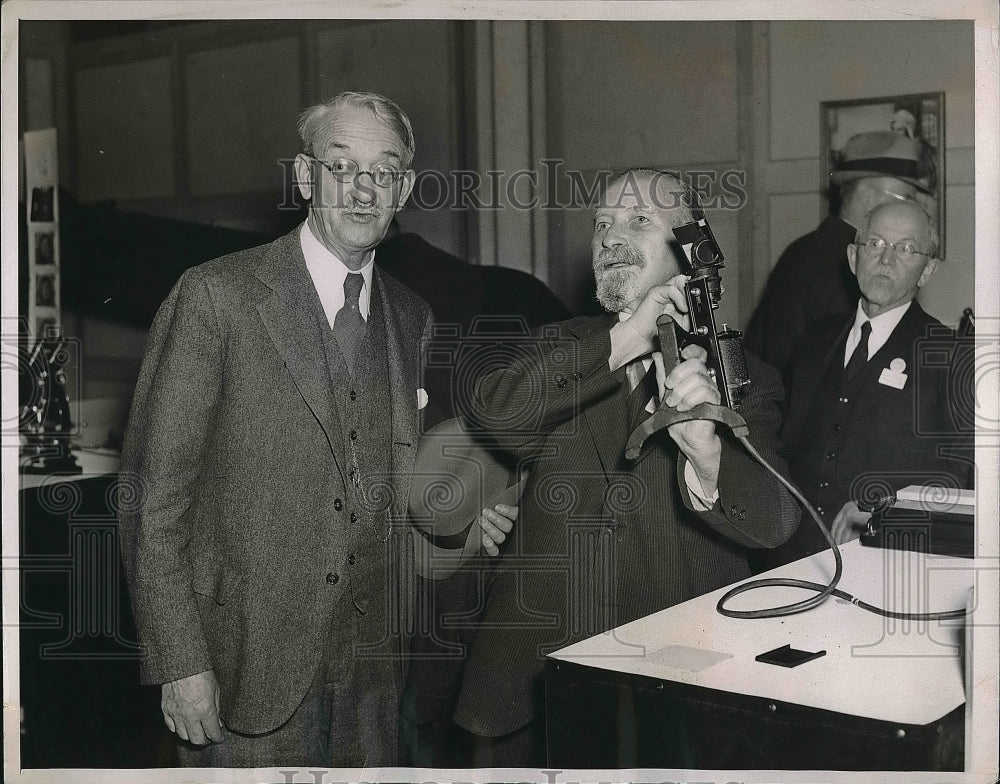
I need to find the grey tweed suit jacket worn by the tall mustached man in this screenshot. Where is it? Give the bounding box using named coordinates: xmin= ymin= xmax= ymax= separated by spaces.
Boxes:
xmin=120 ymin=229 xmax=432 ymax=733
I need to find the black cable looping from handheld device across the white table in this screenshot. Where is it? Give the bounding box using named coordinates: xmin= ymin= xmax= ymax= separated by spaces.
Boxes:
xmin=715 ymin=436 xmax=966 ymax=621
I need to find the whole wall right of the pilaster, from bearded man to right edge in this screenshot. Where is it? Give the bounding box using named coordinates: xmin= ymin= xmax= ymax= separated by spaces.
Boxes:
xmin=545 ymin=22 xmax=974 ymax=325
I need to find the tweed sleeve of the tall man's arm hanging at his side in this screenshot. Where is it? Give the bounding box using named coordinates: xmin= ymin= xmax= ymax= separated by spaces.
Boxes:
xmin=119 ymin=270 xmax=222 ymax=683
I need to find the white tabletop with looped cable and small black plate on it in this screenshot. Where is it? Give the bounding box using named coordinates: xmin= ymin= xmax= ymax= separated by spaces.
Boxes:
xmin=547 ymin=541 xmax=976 ymax=768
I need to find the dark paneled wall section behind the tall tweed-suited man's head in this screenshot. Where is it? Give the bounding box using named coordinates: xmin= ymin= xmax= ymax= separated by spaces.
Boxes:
xmin=22 ymin=20 xmax=465 ymax=253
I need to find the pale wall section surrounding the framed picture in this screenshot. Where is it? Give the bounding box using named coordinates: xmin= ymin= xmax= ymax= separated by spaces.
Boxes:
xmin=754 ymin=21 xmax=975 ymax=324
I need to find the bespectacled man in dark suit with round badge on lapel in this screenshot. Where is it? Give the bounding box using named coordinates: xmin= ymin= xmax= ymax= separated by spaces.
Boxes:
xmin=764 ymin=196 xmax=973 ymax=566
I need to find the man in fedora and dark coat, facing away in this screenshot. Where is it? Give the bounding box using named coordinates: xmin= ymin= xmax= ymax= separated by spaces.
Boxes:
xmin=745 ymin=131 xmax=930 ymax=380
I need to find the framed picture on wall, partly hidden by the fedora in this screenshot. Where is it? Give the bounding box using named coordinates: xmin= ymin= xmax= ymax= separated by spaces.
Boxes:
xmin=820 ymin=93 xmax=945 ymax=258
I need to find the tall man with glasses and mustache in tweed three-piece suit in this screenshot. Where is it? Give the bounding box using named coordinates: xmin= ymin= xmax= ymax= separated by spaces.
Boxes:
xmin=120 ymin=93 xmax=512 ymax=767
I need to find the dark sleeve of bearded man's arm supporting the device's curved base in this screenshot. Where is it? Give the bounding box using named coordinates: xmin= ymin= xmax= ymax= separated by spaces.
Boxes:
xmin=677 ymin=355 xmax=800 ymax=548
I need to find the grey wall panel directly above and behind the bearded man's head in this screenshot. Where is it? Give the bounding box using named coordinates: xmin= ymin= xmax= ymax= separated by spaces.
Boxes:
xmin=546 ymin=22 xmax=747 ymax=325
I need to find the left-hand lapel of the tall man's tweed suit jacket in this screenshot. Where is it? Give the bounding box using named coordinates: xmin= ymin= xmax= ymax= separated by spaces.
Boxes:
xmin=255 ymin=229 xmax=344 ymax=484
